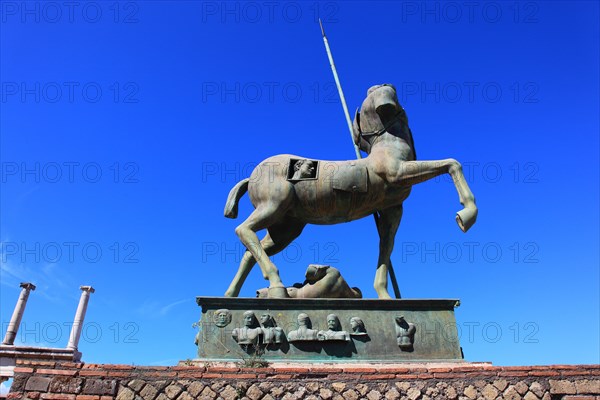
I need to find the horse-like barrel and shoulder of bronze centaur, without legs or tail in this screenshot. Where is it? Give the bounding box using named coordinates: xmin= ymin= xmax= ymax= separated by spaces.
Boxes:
xmin=248 ymin=138 xmax=414 ymax=225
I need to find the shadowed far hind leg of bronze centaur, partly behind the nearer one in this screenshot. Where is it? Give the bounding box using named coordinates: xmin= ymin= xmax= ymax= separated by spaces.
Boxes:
xmin=225 ymin=221 xmax=306 ymax=297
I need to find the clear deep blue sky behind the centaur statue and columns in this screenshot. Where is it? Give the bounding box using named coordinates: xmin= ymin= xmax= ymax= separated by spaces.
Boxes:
xmin=0 ymin=1 xmax=600 ymax=365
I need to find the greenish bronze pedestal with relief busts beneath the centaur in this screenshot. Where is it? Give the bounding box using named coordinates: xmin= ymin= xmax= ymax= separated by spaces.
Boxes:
xmin=196 ymin=297 xmax=463 ymax=363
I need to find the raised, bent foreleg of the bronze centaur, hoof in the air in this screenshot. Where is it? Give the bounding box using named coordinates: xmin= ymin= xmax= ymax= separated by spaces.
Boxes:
xmin=397 ymin=158 xmax=477 ymax=232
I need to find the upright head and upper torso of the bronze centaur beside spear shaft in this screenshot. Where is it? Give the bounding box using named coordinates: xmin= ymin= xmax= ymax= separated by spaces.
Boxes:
xmin=352 ymin=83 xmax=412 ymax=153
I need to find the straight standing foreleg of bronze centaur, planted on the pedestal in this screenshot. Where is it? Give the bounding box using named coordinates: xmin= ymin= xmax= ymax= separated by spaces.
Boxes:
xmin=373 ymin=205 xmax=402 ymax=299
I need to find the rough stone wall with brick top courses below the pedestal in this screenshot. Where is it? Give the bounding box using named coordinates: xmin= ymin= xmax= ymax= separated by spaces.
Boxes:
xmin=8 ymin=361 xmax=600 ymax=400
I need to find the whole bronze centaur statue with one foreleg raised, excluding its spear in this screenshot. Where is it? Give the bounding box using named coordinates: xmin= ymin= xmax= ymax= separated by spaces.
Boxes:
xmin=225 ymin=85 xmax=477 ymax=298
